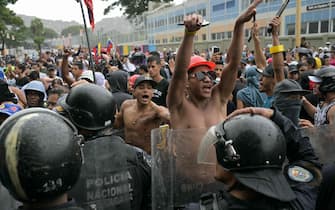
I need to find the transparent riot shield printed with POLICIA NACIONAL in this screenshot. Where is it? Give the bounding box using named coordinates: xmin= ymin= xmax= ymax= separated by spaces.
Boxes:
xmin=69 ymin=136 xmax=134 ymax=210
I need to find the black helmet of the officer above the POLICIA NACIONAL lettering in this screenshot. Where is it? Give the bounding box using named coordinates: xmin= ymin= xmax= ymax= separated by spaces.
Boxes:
xmin=60 ymin=84 xmax=116 ymax=131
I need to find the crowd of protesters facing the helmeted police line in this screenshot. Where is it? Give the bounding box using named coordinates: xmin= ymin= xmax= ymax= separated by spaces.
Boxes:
xmin=0 ymin=1 xmax=335 ymax=209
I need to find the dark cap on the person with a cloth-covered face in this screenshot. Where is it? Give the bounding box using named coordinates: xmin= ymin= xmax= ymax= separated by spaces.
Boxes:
xmin=273 ymin=79 xmax=311 ymax=95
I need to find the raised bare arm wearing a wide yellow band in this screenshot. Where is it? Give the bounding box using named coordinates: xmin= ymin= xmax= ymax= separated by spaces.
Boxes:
xmin=270 ymin=17 xmax=285 ymax=83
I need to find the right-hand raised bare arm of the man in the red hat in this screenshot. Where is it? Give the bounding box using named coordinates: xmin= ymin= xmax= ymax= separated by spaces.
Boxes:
xmin=214 ymin=0 xmax=262 ymax=101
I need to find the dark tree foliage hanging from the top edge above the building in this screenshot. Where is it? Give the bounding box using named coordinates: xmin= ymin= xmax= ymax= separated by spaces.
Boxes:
xmin=102 ymin=0 xmax=173 ymax=20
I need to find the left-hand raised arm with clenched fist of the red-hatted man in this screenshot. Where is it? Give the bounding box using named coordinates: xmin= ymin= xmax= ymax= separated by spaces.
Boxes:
xmin=167 ymin=14 xmax=202 ymax=110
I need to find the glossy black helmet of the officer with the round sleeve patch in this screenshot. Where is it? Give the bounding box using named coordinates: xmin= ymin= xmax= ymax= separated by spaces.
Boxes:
xmin=215 ymin=114 xmax=286 ymax=171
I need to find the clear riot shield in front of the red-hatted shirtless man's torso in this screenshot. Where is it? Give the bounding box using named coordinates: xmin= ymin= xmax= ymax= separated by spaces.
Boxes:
xmin=151 ymin=125 xmax=223 ymax=210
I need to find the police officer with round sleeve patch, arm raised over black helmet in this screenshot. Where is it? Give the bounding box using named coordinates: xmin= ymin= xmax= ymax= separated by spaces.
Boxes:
xmin=198 ymin=108 xmax=321 ymax=209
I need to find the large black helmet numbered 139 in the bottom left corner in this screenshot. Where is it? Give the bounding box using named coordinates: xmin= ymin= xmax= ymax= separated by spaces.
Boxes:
xmin=0 ymin=108 xmax=83 ymax=203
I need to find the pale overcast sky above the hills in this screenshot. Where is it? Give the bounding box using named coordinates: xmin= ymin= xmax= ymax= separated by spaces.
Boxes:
xmin=8 ymin=0 xmax=183 ymax=23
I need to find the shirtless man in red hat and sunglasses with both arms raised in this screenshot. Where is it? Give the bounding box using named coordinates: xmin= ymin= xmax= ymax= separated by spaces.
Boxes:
xmin=167 ymin=0 xmax=261 ymax=129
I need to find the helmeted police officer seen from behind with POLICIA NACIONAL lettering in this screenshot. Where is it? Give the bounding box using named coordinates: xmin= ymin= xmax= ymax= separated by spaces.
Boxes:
xmin=60 ymin=84 xmax=151 ymax=210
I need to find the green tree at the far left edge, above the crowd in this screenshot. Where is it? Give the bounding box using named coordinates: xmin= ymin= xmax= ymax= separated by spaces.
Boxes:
xmin=0 ymin=0 xmax=26 ymax=50
